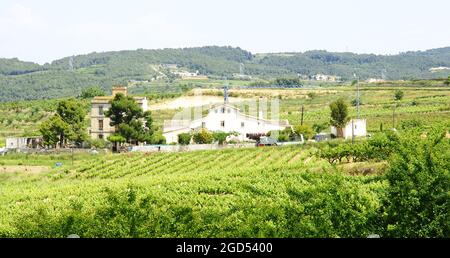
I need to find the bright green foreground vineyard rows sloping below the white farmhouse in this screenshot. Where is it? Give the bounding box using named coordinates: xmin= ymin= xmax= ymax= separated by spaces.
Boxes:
xmin=0 ymin=146 xmax=384 ymax=237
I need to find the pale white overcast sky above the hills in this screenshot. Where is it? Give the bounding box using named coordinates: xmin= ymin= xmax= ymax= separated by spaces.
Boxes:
xmin=0 ymin=0 xmax=450 ymax=63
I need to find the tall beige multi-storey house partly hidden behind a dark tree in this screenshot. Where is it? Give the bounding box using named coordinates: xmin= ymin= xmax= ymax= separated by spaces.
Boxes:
xmin=89 ymin=87 xmax=148 ymax=139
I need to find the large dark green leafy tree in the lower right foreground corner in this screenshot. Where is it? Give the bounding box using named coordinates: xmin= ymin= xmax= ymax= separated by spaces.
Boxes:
xmin=383 ymin=128 xmax=450 ymax=238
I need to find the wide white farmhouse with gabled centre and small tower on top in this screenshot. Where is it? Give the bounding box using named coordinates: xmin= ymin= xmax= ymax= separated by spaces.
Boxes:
xmin=163 ymin=87 xmax=290 ymax=143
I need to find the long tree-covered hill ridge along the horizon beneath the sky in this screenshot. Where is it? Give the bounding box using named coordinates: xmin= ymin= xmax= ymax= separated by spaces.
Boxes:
xmin=0 ymin=46 xmax=450 ymax=101
